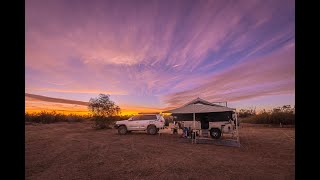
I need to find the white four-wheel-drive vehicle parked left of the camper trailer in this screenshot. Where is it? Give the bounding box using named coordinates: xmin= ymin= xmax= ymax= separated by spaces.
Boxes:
xmin=115 ymin=114 xmax=165 ymax=135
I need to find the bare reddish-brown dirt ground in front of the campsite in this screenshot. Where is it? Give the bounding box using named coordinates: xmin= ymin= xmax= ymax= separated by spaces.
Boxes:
xmin=25 ymin=122 xmax=295 ymax=180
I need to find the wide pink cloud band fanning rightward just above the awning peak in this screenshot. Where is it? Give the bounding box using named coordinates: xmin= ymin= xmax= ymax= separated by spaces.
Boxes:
xmin=164 ymin=44 xmax=295 ymax=106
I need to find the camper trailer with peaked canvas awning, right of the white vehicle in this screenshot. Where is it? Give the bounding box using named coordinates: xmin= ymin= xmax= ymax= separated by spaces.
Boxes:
xmin=165 ymin=98 xmax=239 ymax=139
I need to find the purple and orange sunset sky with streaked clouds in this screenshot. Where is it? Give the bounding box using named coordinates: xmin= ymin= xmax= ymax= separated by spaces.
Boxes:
xmin=25 ymin=0 xmax=295 ymax=114
